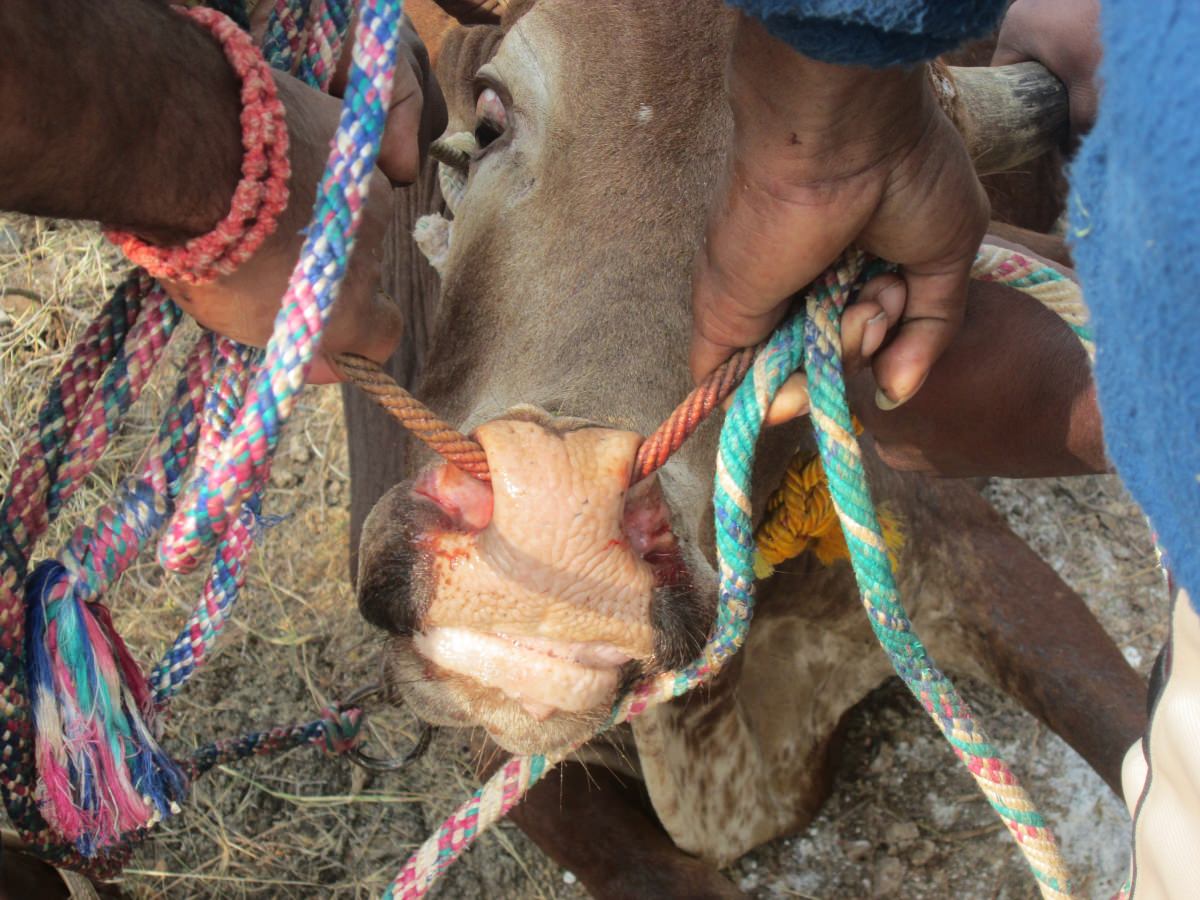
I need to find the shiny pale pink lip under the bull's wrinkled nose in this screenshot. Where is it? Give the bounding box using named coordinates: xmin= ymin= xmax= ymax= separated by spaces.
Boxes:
xmin=413 ymin=628 xmax=630 ymax=721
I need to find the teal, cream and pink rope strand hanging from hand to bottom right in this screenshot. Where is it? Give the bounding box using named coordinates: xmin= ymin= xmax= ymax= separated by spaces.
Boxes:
xmin=806 ymin=251 xmax=1070 ymax=898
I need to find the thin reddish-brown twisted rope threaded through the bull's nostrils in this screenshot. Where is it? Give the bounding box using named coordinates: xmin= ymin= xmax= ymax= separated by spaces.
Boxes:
xmin=334 ymin=347 xmax=758 ymax=484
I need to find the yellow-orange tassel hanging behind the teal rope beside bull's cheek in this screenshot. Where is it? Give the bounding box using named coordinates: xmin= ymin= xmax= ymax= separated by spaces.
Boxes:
xmin=754 ymin=434 xmax=904 ymax=578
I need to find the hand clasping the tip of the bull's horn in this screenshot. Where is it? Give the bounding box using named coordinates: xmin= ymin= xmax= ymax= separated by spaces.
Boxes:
xmin=991 ymin=0 xmax=1102 ymax=137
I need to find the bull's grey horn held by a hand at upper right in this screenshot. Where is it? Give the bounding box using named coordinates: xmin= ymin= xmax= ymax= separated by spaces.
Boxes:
xmin=934 ymin=62 xmax=1069 ymax=175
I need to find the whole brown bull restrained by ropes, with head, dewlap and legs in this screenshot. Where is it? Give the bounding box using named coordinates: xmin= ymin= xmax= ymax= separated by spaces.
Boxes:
xmin=347 ymin=0 xmax=1145 ymax=896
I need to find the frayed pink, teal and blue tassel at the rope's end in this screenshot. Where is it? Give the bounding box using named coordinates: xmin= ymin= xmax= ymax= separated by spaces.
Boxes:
xmin=25 ymin=560 xmax=187 ymax=857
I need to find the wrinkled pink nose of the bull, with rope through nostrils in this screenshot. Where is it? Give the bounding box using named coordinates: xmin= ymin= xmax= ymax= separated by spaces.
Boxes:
xmin=413 ymin=419 xmax=673 ymax=658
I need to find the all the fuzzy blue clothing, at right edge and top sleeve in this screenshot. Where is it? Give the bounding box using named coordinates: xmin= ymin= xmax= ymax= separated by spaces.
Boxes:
xmin=731 ymin=0 xmax=1200 ymax=612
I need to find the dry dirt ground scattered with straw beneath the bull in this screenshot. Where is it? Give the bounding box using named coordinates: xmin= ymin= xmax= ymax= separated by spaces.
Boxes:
xmin=0 ymin=216 xmax=1166 ymax=900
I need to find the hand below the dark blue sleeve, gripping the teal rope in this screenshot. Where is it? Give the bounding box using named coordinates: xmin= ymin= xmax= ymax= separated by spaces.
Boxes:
xmin=691 ymin=18 xmax=989 ymax=421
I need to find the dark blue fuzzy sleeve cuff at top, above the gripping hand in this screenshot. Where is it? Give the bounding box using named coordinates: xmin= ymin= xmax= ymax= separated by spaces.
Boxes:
xmin=728 ymin=0 xmax=1007 ymax=68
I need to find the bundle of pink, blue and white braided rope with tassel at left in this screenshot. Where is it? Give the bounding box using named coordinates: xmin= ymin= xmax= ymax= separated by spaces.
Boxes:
xmin=0 ymin=0 xmax=376 ymax=876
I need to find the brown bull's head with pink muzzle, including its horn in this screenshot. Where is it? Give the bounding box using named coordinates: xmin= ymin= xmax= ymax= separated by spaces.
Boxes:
xmin=359 ymin=0 xmax=1066 ymax=752
